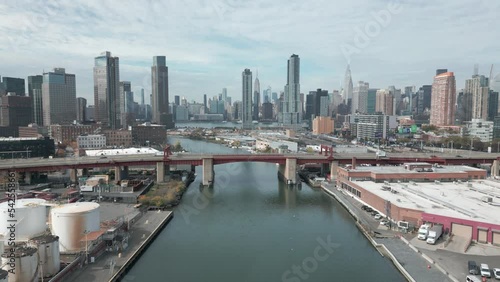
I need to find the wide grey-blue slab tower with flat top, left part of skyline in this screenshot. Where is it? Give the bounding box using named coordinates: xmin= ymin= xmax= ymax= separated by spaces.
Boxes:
xmin=42 ymin=68 xmax=76 ymax=126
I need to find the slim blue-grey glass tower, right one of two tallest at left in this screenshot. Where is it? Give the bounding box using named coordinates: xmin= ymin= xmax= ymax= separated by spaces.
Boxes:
xmin=151 ymin=56 xmax=174 ymax=128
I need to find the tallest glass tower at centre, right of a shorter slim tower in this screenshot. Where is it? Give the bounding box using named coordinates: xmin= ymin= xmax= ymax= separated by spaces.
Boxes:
xmin=279 ymin=54 xmax=303 ymax=128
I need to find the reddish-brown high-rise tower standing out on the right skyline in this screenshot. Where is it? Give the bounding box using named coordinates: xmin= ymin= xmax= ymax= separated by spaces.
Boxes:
xmin=430 ymin=72 xmax=456 ymax=126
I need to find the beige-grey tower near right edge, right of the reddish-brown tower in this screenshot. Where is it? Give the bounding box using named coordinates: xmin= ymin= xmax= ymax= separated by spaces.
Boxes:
xmin=464 ymin=74 xmax=490 ymax=121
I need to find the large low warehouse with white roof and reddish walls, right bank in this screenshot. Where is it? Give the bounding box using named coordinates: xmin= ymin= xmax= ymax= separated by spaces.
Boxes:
xmin=337 ymin=161 xmax=500 ymax=245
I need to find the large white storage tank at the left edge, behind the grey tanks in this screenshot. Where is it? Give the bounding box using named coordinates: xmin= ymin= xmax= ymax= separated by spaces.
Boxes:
xmin=0 ymin=199 xmax=47 ymax=241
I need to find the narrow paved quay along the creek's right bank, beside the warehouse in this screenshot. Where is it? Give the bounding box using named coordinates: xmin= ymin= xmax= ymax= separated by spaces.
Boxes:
xmin=321 ymin=183 xmax=455 ymax=282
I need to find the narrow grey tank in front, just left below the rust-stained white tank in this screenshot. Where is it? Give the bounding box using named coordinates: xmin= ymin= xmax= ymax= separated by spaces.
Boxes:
xmin=28 ymin=235 xmax=61 ymax=277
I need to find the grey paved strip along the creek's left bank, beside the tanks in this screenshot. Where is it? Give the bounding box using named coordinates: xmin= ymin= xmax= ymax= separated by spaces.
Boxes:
xmin=64 ymin=211 xmax=172 ymax=282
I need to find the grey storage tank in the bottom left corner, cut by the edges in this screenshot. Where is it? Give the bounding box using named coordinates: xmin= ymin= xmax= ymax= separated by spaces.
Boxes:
xmin=2 ymin=245 xmax=38 ymax=282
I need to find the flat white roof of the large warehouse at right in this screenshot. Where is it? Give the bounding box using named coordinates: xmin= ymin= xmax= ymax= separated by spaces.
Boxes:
xmin=353 ymin=180 xmax=500 ymax=224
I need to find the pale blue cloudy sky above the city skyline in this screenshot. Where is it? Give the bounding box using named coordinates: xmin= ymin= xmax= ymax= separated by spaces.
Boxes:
xmin=0 ymin=0 xmax=500 ymax=104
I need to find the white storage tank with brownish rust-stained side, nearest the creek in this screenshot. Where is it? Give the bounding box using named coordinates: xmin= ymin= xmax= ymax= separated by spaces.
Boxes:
xmin=50 ymin=202 xmax=101 ymax=253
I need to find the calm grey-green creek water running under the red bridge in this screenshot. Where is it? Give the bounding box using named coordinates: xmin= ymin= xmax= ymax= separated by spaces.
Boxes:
xmin=127 ymin=137 xmax=406 ymax=282
